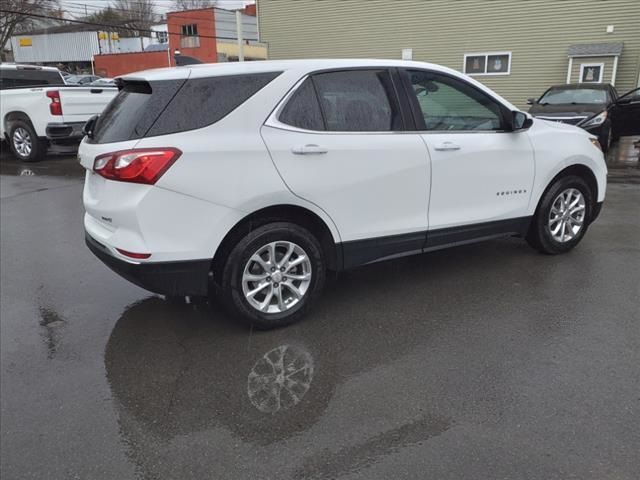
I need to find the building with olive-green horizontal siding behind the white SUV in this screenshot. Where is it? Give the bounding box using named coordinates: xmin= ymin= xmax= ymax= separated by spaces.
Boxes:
xmin=257 ymin=0 xmax=640 ymax=107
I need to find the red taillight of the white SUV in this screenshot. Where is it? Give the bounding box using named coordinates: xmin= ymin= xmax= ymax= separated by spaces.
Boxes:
xmin=93 ymin=148 xmax=182 ymax=185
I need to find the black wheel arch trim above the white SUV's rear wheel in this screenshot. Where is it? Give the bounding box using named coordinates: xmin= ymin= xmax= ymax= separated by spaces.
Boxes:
xmin=212 ymin=204 xmax=342 ymax=279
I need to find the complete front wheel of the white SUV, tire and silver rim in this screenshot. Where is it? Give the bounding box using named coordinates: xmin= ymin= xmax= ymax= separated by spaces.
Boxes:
xmin=527 ymin=175 xmax=594 ymax=255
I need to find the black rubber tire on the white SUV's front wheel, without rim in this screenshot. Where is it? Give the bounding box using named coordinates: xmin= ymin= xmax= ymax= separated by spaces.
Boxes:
xmin=526 ymin=175 xmax=594 ymax=255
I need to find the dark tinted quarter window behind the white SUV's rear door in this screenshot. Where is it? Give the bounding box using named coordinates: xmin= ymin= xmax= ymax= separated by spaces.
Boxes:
xmin=147 ymin=72 xmax=281 ymax=137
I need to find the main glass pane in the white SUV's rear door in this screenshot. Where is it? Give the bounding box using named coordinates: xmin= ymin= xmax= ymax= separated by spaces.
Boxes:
xmin=313 ymin=70 xmax=403 ymax=132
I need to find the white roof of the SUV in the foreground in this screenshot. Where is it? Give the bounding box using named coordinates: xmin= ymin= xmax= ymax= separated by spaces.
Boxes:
xmin=120 ymin=58 xmax=468 ymax=80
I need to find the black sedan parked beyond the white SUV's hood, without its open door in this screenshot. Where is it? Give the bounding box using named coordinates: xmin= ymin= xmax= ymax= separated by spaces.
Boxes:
xmin=527 ymin=83 xmax=618 ymax=151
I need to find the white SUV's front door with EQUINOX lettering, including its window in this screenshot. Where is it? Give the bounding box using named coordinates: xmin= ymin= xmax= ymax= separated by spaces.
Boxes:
xmin=407 ymin=71 xmax=535 ymax=230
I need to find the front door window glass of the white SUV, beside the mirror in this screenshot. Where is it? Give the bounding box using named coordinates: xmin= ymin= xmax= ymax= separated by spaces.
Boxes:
xmin=407 ymin=70 xmax=502 ymax=131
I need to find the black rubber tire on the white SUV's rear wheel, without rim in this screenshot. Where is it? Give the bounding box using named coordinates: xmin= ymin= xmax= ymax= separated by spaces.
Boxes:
xmin=218 ymin=222 xmax=326 ymax=330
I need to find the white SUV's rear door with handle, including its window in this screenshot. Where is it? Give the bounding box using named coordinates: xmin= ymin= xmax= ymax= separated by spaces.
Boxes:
xmin=262 ymin=70 xmax=430 ymax=255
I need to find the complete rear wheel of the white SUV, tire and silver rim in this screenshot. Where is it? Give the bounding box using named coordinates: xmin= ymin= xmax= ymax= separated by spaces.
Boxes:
xmin=221 ymin=222 xmax=325 ymax=329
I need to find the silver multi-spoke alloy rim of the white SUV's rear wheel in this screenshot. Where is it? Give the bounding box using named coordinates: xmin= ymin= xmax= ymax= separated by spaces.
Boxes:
xmin=242 ymin=241 xmax=312 ymax=313
